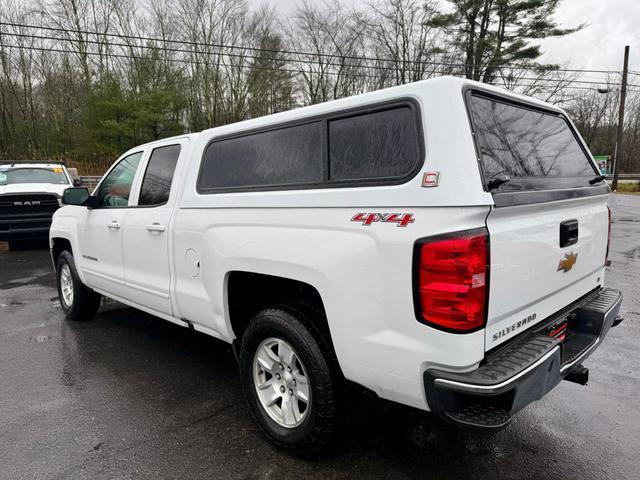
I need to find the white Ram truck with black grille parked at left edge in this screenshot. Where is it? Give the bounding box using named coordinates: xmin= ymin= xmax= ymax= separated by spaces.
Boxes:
xmin=0 ymin=161 xmax=78 ymax=241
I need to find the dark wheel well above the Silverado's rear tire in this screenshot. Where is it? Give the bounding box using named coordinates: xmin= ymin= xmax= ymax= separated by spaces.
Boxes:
xmin=227 ymin=271 xmax=335 ymax=355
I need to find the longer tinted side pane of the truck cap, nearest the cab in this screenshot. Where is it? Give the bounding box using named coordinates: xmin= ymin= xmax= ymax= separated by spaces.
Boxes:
xmin=198 ymin=122 xmax=323 ymax=190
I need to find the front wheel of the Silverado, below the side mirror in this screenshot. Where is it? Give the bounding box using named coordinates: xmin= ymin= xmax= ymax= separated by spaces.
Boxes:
xmin=56 ymin=250 xmax=102 ymax=320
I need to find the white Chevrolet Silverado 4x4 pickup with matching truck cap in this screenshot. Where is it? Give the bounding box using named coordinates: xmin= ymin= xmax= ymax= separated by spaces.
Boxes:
xmin=50 ymin=77 xmax=622 ymax=452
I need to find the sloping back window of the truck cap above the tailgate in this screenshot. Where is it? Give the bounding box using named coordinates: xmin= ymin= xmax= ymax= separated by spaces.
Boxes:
xmin=467 ymin=94 xmax=597 ymax=189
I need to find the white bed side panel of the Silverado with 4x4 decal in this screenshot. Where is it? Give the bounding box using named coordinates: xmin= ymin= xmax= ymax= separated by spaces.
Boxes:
xmin=173 ymin=207 xmax=488 ymax=408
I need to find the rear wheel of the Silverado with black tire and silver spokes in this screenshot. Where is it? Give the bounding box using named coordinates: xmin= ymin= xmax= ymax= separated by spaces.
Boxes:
xmin=239 ymin=308 xmax=340 ymax=456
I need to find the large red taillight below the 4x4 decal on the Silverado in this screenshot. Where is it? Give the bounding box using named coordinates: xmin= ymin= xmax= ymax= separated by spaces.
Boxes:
xmin=414 ymin=229 xmax=489 ymax=333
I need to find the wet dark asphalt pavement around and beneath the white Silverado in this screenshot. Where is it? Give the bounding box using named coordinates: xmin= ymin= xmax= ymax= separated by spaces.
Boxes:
xmin=0 ymin=195 xmax=640 ymax=480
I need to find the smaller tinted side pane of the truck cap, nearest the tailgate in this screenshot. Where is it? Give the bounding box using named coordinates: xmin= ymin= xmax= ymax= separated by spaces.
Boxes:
xmin=329 ymin=107 xmax=420 ymax=180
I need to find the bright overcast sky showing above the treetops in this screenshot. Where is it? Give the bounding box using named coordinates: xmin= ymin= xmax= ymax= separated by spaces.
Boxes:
xmin=256 ymin=0 xmax=640 ymax=73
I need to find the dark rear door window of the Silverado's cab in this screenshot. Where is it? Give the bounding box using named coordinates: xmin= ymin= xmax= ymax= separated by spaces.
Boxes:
xmin=138 ymin=145 xmax=180 ymax=206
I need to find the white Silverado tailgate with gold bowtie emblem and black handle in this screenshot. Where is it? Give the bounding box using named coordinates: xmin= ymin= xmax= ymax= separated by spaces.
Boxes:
xmin=485 ymin=195 xmax=609 ymax=350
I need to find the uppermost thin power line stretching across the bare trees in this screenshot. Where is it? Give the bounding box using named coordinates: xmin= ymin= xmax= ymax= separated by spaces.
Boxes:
xmin=0 ymin=22 xmax=632 ymax=74
